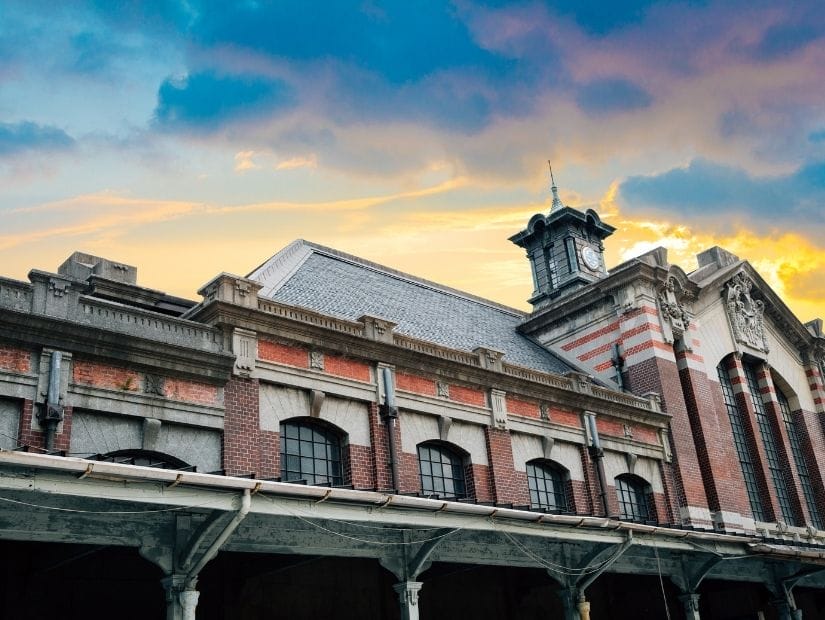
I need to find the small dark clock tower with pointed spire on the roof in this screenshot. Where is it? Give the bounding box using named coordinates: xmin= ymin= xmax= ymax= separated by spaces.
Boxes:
xmin=510 ymin=168 xmax=616 ymax=311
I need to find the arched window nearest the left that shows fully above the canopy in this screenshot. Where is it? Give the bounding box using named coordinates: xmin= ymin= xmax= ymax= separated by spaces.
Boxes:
xmin=281 ymin=420 xmax=344 ymax=486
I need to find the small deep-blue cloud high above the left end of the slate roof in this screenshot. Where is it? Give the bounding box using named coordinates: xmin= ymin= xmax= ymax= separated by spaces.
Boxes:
xmin=155 ymin=71 xmax=293 ymax=131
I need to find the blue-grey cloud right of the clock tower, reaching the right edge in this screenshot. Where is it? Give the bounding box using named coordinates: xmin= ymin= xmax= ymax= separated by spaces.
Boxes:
xmin=619 ymin=159 xmax=825 ymax=230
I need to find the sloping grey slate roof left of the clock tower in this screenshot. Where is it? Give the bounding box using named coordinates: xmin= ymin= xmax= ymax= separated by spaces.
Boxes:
xmin=248 ymin=240 xmax=576 ymax=374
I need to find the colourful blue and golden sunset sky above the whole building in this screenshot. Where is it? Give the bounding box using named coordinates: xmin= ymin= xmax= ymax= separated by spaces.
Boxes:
xmin=0 ymin=0 xmax=825 ymax=321
